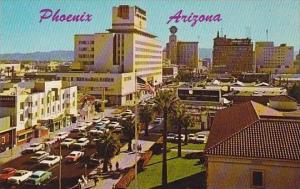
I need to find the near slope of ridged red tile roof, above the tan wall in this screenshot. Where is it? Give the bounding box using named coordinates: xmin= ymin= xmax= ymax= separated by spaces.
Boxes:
xmin=205 ymin=119 xmax=300 ymax=160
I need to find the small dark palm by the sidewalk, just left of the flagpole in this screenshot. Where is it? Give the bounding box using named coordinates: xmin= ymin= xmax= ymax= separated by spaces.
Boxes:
xmin=121 ymin=117 xmax=135 ymax=152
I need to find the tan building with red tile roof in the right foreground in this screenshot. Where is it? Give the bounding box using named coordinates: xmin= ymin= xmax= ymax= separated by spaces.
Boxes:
xmin=205 ymin=101 xmax=300 ymax=189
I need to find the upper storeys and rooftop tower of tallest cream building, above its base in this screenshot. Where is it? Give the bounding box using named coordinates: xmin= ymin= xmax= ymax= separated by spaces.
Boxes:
xmin=73 ymin=5 xmax=162 ymax=85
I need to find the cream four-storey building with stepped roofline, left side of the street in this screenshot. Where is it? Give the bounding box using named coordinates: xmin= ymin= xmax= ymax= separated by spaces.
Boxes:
xmin=0 ymin=81 xmax=77 ymax=144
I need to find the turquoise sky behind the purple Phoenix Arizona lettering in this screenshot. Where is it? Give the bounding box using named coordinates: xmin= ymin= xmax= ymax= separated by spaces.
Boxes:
xmin=0 ymin=0 xmax=300 ymax=54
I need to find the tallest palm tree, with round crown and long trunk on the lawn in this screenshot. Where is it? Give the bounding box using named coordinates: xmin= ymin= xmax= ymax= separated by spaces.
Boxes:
xmin=154 ymin=90 xmax=179 ymax=187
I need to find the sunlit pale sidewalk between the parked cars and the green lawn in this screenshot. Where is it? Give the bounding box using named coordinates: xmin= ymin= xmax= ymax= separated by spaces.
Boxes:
xmin=88 ymin=140 xmax=154 ymax=189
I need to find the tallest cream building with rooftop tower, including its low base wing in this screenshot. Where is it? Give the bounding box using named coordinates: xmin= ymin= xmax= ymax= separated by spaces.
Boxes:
xmin=66 ymin=5 xmax=162 ymax=105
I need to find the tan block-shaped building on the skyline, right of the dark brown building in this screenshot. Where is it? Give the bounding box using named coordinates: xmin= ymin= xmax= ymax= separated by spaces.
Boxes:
xmin=255 ymin=42 xmax=294 ymax=73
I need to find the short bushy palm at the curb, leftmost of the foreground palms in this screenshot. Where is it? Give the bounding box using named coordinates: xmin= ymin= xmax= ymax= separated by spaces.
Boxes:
xmin=96 ymin=132 xmax=121 ymax=172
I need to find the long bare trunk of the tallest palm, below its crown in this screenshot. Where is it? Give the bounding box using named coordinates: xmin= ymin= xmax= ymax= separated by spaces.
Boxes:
xmin=162 ymin=112 xmax=168 ymax=188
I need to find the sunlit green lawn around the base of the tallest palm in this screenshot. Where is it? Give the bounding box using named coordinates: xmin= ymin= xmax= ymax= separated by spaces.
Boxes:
xmin=128 ymin=151 xmax=204 ymax=189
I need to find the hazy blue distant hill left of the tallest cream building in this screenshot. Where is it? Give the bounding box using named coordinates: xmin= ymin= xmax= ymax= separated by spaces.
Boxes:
xmin=0 ymin=50 xmax=74 ymax=61
